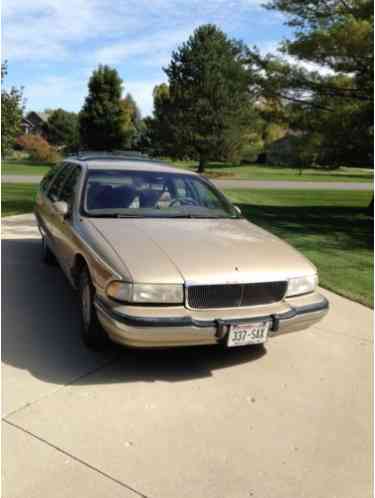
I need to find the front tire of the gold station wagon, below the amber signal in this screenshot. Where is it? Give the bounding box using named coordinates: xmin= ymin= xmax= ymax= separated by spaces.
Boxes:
xmin=79 ymin=268 xmax=109 ymax=351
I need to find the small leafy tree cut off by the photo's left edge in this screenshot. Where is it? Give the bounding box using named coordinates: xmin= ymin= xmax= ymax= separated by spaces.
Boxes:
xmin=1 ymin=61 xmax=24 ymax=157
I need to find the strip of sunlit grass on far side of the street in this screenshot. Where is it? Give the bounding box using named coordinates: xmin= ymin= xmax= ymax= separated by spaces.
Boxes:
xmin=1 ymin=159 xmax=373 ymax=182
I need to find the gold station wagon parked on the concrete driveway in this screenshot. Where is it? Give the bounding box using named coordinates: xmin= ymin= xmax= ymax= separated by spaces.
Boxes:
xmin=35 ymin=153 xmax=328 ymax=350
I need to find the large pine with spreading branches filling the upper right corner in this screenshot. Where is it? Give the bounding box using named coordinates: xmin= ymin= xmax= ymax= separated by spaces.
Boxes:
xmin=248 ymin=0 xmax=374 ymax=165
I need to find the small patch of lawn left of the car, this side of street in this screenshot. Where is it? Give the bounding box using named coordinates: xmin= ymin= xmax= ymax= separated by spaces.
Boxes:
xmin=1 ymin=183 xmax=38 ymax=217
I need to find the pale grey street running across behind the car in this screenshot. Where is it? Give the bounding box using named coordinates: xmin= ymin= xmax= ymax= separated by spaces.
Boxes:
xmin=1 ymin=175 xmax=374 ymax=190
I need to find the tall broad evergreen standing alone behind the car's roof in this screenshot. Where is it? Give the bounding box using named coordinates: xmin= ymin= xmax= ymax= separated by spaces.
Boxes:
xmin=166 ymin=24 xmax=249 ymax=172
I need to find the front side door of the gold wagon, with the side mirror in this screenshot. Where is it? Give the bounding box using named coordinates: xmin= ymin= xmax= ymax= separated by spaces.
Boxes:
xmin=50 ymin=164 xmax=82 ymax=275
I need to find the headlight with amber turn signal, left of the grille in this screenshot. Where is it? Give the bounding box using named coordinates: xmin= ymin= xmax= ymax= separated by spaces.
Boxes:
xmin=107 ymin=282 xmax=184 ymax=304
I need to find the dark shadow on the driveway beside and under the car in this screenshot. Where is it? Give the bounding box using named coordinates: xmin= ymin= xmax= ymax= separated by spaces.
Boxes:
xmin=2 ymin=238 xmax=266 ymax=385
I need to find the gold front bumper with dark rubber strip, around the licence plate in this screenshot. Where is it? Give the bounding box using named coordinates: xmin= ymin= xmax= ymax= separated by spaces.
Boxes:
xmin=95 ymin=293 xmax=329 ymax=348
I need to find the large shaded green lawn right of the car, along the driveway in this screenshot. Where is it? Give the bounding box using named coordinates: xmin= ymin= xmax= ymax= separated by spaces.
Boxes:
xmin=226 ymin=190 xmax=374 ymax=307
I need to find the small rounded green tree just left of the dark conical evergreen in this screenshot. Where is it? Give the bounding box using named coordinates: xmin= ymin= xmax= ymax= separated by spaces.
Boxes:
xmin=46 ymin=109 xmax=79 ymax=151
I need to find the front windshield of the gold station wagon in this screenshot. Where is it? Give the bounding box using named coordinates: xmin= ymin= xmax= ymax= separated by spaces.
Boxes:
xmin=83 ymin=170 xmax=239 ymax=218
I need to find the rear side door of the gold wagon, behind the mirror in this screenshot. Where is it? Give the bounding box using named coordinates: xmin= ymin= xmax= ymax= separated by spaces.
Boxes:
xmin=43 ymin=163 xmax=73 ymax=259
